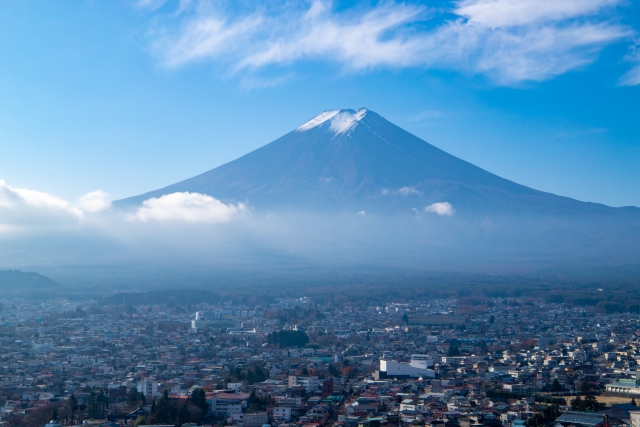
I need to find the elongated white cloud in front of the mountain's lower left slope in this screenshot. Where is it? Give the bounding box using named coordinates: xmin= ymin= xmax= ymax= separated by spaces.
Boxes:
xmin=125 ymin=193 xmax=245 ymax=223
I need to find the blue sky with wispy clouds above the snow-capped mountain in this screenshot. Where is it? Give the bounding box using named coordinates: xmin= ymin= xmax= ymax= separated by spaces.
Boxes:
xmin=0 ymin=0 xmax=640 ymax=206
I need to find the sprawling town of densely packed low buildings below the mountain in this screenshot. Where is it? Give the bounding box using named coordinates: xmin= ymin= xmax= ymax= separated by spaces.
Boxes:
xmin=0 ymin=294 xmax=640 ymax=427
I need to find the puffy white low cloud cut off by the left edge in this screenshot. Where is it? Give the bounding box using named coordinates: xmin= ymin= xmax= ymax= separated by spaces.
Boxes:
xmin=0 ymin=180 xmax=83 ymax=231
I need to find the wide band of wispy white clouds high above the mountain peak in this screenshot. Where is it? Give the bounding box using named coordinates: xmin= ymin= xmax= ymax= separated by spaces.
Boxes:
xmin=146 ymin=0 xmax=634 ymax=85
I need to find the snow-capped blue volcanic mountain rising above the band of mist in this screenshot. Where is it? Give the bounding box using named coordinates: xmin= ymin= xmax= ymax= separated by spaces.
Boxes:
xmin=116 ymin=108 xmax=633 ymax=215
